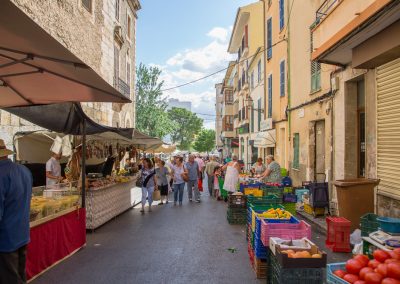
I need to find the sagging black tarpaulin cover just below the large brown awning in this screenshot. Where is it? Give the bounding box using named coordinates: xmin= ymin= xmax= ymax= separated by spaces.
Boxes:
xmin=4 ymin=103 xmax=133 ymax=139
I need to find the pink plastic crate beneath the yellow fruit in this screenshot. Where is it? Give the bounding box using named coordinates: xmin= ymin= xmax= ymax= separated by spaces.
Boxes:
xmin=261 ymin=219 xmax=311 ymax=246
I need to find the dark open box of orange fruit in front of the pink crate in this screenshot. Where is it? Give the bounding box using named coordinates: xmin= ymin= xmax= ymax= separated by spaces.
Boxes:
xmin=275 ymin=241 xmax=327 ymax=268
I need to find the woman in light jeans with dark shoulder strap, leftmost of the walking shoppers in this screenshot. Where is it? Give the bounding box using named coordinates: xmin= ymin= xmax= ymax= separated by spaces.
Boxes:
xmin=140 ymin=158 xmax=157 ymax=213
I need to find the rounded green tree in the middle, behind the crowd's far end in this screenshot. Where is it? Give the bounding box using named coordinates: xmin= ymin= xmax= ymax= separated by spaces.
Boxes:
xmin=168 ymin=107 xmax=203 ymax=150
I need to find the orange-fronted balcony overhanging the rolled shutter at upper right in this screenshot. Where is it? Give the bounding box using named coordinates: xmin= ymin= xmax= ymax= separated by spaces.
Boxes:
xmin=311 ymin=0 xmax=400 ymax=68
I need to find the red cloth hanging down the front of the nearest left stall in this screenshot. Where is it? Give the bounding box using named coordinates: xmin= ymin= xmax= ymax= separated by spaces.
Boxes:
xmin=26 ymin=208 xmax=86 ymax=279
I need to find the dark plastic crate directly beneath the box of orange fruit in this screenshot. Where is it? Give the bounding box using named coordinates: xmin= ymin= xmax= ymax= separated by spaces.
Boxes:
xmin=268 ymin=251 xmax=325 ymax=284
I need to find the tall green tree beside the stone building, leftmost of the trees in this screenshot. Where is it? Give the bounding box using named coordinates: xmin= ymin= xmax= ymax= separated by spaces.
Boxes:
xmin=136 ymin=63 xmax=175 ymax=138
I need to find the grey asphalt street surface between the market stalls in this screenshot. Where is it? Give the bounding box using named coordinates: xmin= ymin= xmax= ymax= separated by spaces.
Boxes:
xmin=32 ymin=181 xmax=348 ymax=284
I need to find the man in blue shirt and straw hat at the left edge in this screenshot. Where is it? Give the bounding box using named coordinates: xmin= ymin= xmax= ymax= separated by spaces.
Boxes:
xmin=0 ymin=139 xmax=33 ymax=284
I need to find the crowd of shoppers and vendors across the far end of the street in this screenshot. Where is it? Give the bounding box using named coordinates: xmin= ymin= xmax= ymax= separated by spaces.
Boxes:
xmin=139 ymin=154 xmax=282 ymax=213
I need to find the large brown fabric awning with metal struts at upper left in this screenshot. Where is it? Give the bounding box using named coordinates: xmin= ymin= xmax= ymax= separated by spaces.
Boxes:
xmin=0 ymin=0 xmax=130 ymax=107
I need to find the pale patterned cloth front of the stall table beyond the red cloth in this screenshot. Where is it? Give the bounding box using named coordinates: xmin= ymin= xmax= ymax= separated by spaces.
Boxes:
xmin=86 ymin=176 xmax=138 ymax=230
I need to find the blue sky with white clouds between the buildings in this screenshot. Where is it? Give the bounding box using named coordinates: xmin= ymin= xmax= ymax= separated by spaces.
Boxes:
xmin=136 ymin=0 xmax=256 ymax=128
